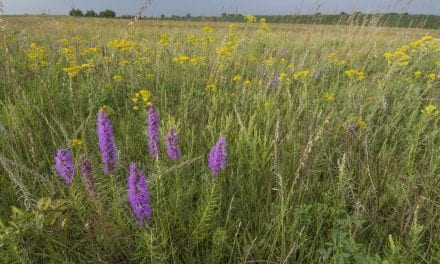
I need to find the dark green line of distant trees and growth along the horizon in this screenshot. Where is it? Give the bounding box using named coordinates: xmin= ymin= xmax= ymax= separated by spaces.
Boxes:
xmin=69 ymin=8 xmax=440 ymax=29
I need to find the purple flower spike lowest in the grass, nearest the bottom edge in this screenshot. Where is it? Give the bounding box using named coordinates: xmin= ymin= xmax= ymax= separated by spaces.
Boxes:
xmin=128 ymin=162 xmax=152 ymax=225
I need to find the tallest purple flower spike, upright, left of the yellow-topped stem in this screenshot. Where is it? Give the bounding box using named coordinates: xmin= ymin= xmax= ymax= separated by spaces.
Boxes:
xmin=96 ymin=109 xmax=116 ymax=174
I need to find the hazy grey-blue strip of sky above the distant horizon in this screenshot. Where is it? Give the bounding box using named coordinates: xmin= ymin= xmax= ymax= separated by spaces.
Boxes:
xmin=0 ymin=0 xmax=440 ymax=16
